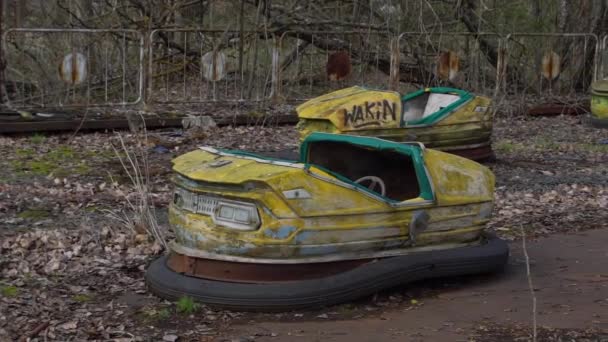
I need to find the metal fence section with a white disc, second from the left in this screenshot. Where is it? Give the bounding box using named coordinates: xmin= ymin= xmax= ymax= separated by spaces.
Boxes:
xmin=147 ymin=29 xmax=276 ymax=104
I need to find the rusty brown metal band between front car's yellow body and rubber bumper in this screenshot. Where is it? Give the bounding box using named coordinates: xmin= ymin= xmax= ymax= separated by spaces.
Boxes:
xmin=167 ymin=252 xmax=375 ymax=283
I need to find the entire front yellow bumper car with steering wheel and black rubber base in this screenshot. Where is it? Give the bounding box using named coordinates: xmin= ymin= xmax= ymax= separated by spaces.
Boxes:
xmin=146 ymin=133 xmax=508 ymax=310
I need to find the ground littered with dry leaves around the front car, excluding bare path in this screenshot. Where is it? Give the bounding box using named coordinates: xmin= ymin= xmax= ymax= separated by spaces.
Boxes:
xmin=0 ymin=117 xmax=608 ymax=341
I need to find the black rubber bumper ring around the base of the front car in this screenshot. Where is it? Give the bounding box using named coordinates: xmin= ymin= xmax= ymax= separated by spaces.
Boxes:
xmin=146 ymin=235 xmax=509 ymax=311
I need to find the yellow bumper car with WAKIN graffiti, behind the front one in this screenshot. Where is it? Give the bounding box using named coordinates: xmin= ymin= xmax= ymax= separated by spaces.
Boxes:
xmin=296 ymin=86 xmax=493 ymax=160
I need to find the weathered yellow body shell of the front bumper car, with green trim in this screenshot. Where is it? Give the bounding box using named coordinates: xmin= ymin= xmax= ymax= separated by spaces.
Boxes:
xmin=169 ymin=133 xmax=494 ymax=263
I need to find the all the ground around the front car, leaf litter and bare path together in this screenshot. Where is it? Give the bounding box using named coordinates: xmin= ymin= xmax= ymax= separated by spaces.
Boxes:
xmin=0 ymin=116 xmax=608 ymax=341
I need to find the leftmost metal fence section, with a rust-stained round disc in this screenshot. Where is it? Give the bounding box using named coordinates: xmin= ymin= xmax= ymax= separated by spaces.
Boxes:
xmin=3 ymin=29 xmax=144 ymax=108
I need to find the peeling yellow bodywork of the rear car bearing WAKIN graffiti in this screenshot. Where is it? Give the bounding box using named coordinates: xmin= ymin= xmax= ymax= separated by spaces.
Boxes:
xmin=296 ymin=87 xmax=493 ymax=150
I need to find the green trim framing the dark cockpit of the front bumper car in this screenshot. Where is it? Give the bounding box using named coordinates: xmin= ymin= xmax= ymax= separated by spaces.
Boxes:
xmin=300 ymin=132 xmax=434 ymax=203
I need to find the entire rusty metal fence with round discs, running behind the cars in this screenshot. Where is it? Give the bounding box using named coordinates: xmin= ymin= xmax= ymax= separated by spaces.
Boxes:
xmin=2 ymin=28 xmax=608 ymax=108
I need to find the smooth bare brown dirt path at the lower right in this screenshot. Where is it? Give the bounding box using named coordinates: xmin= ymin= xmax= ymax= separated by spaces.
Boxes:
xmin=227 ymin=230 xmax=608 ymax=342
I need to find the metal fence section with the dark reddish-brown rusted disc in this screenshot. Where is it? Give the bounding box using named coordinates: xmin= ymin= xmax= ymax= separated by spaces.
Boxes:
xmin=277 ymin=31 xmax=392 ymax=100
